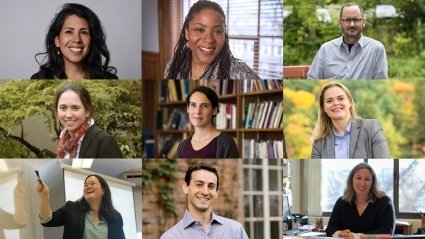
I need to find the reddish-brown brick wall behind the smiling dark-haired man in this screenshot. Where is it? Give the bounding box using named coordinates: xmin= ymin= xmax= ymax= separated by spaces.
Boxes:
xmin=142 ymin=159 xmax=243 ymax=239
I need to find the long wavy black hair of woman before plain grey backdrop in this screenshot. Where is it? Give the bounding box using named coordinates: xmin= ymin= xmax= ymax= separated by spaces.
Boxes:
xmin=31 ymin=3 xmax=117 ymax=79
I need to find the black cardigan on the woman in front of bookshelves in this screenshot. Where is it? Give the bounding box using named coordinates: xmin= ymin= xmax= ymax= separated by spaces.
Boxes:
xmin=177 ymin=132 xmax=239 ymax=158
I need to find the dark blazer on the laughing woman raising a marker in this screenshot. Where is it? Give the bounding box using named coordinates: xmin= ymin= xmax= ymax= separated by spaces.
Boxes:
xmin=42 ymin=201 xmax=125 ymax=239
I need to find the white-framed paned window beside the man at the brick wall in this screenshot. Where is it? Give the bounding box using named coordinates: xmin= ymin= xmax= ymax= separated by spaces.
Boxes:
xmin=243 ymin=159 xmax=283 ymax=239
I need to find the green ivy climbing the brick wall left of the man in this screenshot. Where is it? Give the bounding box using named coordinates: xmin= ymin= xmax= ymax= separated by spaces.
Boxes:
xmin=142 ymin=159 xmax=177 ymax=216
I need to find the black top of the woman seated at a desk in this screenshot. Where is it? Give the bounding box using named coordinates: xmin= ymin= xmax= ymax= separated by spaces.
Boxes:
xmin=326 ymin=196 xmax=395 ymax=236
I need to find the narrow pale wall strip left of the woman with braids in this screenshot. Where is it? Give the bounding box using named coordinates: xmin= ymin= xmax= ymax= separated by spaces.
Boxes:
xmin=142 ymin=0 xmax=159 ymax=52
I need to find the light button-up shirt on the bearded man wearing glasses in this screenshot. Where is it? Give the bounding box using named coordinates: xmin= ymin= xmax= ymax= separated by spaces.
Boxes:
xmin=307 ymin=35 xmax=388 ymax=80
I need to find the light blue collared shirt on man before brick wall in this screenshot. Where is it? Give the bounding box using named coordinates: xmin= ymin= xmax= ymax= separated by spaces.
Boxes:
xmin=161 ymin=209 xmax=248 ymax=239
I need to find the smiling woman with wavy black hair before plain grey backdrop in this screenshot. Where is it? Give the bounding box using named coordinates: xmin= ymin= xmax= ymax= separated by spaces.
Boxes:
xmin=31 ymin=3 xmax=118 ymax=79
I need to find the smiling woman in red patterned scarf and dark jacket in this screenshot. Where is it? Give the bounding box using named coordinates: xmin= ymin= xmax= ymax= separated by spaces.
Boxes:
xmin=54 ymin=83 xmax=121 ymax=158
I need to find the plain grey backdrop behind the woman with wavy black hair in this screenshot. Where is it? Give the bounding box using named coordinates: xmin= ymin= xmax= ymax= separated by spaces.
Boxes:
xmin=0 ymin=0 xmax=142 ymax=79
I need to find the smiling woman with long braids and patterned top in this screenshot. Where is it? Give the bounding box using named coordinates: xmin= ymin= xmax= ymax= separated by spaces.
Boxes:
xmin=164 ymin=0 xmax=260 ymax=80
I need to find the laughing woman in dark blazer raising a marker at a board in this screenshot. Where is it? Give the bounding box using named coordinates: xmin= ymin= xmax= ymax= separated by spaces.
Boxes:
xmin=36 ymin=174 xmax=125 ymax=239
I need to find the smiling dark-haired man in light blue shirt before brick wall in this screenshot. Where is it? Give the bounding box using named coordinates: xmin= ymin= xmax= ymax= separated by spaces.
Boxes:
xmin=161 ymin=164 xmax=248 ymax=239
